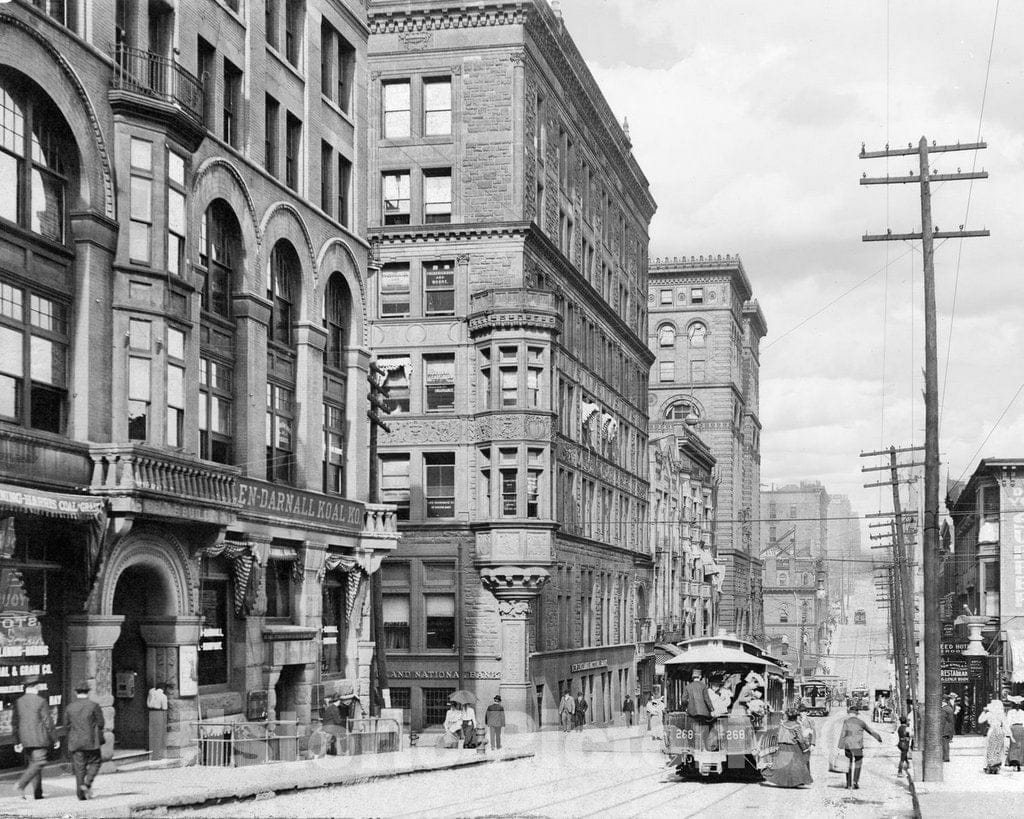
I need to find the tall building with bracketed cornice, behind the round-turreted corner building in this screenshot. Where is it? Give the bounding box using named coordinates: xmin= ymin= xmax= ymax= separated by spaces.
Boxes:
xmin=647 ymin=256 xmax=767 ymax=638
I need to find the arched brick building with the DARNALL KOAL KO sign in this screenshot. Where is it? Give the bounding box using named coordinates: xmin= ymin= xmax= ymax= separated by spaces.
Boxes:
xmin=0 ymin=0 xmax=398 ymax=765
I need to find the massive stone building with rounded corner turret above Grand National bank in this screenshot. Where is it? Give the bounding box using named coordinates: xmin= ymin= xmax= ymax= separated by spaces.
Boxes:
xmin=368 ymin=0 xmax=654 ymax=728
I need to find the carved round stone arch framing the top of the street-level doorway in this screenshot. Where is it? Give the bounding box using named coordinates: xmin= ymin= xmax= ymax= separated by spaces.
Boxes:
xmin=94 ymin=529 xmax=199 ymax=615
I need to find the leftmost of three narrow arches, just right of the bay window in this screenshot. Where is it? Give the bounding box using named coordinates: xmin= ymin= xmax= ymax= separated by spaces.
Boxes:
xmin=189 ymin=157 xmax=263 ymax=293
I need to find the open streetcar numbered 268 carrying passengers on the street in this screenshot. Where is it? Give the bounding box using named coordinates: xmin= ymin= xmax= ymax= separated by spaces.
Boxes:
xmin=664 ymin=636 xmax=793 ymax=778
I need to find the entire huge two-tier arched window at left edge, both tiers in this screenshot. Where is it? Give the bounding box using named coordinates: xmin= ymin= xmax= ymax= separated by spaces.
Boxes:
xmin=0 ymin=70 xmax=79 ymax=434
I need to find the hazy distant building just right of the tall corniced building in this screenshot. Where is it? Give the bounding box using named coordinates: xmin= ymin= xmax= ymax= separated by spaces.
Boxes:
xmin=761 ymin=481 xmax=835 ymax=674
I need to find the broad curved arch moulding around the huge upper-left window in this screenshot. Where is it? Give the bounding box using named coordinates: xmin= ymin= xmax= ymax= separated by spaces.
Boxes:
xmin=0 ymin=13 xmax=117 ymax=219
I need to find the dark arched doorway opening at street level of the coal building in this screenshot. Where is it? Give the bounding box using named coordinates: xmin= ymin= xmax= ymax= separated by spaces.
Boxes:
xmin=111 ymin=563 xmax=175 ymax=748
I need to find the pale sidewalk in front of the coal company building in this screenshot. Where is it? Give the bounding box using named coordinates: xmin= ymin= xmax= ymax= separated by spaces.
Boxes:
xmin=0 ymin=737 xmax=534 ymax=817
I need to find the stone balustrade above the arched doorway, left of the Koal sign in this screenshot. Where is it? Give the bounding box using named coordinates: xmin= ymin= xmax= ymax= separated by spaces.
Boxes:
xmin=89 ymin=444 xmax=238 ymax=505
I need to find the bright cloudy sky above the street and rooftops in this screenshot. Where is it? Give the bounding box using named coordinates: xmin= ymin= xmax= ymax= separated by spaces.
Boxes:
xmin=561 ymin=0 xmax=1024 ymax=532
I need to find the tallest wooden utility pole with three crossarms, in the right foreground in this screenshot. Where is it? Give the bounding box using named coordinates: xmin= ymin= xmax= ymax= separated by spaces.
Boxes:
xmin=860 ymin=136 xmax=988 ymax=782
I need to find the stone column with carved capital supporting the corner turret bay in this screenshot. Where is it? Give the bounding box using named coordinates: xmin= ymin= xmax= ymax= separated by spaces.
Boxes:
xmin=480 ymin=566 xmax=551 ymax=730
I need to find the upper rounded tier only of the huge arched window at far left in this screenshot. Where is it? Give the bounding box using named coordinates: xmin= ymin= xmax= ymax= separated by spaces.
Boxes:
xmin=0 ymin=72 xmax=78 ymax=244
